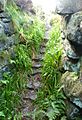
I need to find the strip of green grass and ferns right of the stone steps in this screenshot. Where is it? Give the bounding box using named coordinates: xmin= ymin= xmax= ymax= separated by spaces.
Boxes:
xmin=33 ymin=17 xmax=65 ymax=120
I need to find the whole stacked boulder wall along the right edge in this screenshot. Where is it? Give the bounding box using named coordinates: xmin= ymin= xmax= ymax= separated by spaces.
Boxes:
xmin=56 ymin=0 xmax=82 ymax=120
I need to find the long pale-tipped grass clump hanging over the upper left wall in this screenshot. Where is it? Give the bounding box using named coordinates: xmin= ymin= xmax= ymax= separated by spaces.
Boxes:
xmin=7 ymin=4 xmax=45 ymax=52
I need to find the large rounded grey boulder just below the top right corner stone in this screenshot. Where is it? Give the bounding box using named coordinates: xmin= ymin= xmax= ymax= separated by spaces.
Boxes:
xmin=65 ymin=11 xmax=82 ymax=45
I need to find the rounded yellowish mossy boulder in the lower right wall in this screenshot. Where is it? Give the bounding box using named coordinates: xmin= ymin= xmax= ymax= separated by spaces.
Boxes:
xmin=61 ymin=71 xmax=82 ymax=99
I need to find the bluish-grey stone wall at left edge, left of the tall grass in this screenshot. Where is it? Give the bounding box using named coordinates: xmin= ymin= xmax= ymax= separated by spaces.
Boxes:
xmin=0 ymin=0 xmax=17 ymax=79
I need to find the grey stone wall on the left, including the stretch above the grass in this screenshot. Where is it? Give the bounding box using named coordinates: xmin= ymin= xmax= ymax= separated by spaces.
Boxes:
xmin=0 ymin=0 xmax=35 ymax=80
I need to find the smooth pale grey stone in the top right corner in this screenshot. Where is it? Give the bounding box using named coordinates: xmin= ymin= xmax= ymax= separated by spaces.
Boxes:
xmin=56 ymin=0 xmax=82 ymax=14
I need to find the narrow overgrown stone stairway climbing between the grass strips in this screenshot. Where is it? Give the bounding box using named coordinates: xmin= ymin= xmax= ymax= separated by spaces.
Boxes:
xmin=22 ymin=23 xmax=49 ymax=120
